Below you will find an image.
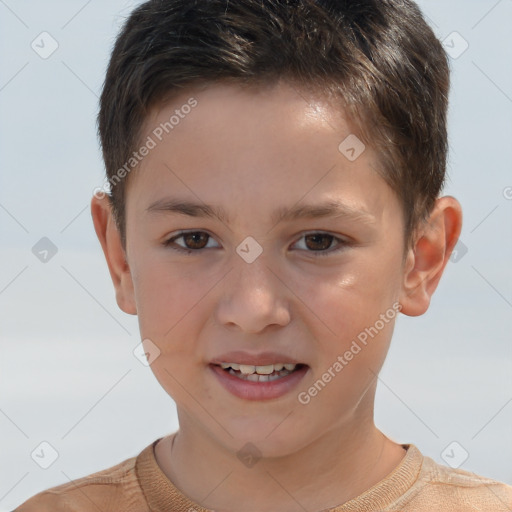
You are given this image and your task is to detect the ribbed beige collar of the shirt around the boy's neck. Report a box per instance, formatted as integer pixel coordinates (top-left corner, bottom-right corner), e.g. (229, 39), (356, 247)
(135, 433), (423, 512)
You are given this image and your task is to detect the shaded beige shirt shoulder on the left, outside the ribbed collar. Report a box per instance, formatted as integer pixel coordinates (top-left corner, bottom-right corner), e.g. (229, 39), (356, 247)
(14, 450), (146, 512)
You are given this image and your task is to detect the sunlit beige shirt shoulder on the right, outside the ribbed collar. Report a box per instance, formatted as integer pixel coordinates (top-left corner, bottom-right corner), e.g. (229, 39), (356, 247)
(404, 450), (512, 512)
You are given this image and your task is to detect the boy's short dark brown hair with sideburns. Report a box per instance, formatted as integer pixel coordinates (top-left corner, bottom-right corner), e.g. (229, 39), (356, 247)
(98, 0), (450, 252)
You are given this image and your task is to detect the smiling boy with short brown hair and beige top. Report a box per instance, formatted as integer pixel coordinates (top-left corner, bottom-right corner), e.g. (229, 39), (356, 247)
(17, 0), (512, 512)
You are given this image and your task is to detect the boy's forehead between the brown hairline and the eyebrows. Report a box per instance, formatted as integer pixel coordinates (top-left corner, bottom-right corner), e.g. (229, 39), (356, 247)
(127, 83), (396, 228)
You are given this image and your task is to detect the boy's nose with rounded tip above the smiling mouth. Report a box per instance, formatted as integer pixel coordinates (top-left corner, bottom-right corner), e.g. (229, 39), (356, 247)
(216, 256), (291, 334)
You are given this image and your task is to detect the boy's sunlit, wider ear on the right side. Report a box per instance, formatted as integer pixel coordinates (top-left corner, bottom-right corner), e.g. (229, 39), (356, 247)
(400, 196), (462, 316)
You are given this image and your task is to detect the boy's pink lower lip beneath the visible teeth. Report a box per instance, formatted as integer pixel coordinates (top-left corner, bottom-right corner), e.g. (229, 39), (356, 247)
(209, 364), (309, 400)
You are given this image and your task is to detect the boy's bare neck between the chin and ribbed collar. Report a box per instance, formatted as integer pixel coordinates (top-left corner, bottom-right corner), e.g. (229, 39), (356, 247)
(156, 418), (405, 512)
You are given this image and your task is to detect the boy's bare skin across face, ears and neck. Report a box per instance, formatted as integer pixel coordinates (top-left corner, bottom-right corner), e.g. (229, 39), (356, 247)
(91, 83), (462, 512)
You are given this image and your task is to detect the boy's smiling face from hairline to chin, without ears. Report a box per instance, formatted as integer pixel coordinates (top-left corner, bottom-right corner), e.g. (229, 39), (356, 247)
(123, 85), (404, 455)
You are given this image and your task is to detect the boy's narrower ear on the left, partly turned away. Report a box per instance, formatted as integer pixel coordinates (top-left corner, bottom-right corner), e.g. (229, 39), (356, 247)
(91, 194), (137, 315)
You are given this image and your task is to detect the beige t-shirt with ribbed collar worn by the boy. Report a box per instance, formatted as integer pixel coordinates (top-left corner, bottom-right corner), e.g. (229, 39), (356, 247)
(14, 432), (512, 512)
